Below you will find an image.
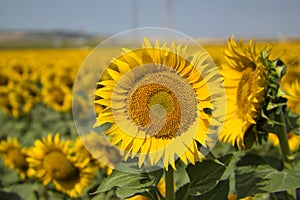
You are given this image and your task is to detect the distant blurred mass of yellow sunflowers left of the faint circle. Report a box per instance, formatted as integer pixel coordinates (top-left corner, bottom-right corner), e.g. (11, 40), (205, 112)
(0, 49), (89, 118)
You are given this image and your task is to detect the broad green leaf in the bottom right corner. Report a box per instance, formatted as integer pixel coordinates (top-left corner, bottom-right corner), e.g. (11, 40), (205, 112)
(235, 164), (300, 198)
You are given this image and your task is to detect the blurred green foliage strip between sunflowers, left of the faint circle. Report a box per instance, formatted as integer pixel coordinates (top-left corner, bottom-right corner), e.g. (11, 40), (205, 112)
(0, 104), (77, 145)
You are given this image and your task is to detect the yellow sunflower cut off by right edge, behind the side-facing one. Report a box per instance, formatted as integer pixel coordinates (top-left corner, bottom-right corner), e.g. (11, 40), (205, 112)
(282, 79), (300, 116)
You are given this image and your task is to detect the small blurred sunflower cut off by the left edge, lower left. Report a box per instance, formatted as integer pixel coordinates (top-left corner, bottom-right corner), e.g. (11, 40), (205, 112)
(0, 137), (28, 179)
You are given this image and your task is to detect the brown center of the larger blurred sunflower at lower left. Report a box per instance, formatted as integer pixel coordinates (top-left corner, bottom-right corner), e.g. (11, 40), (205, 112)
(43, 151), (79, 181)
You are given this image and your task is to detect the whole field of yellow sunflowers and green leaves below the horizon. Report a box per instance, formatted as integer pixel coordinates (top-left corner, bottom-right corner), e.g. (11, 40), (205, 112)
(0, 37), (300, 200)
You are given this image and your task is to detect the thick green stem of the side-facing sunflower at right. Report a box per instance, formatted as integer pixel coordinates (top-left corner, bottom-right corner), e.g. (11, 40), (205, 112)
(276, 112), (293, 168)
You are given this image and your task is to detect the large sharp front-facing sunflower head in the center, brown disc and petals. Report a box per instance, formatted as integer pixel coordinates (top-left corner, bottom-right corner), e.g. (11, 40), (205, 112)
(95, 38), (224, 169)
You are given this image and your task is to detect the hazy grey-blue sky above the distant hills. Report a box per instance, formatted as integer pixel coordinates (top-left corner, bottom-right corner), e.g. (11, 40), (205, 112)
(0, 0), (300, 37)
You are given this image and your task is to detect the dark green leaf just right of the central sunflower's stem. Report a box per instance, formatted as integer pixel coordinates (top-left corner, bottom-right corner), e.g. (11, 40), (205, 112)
(186, 155), (232, 196)
